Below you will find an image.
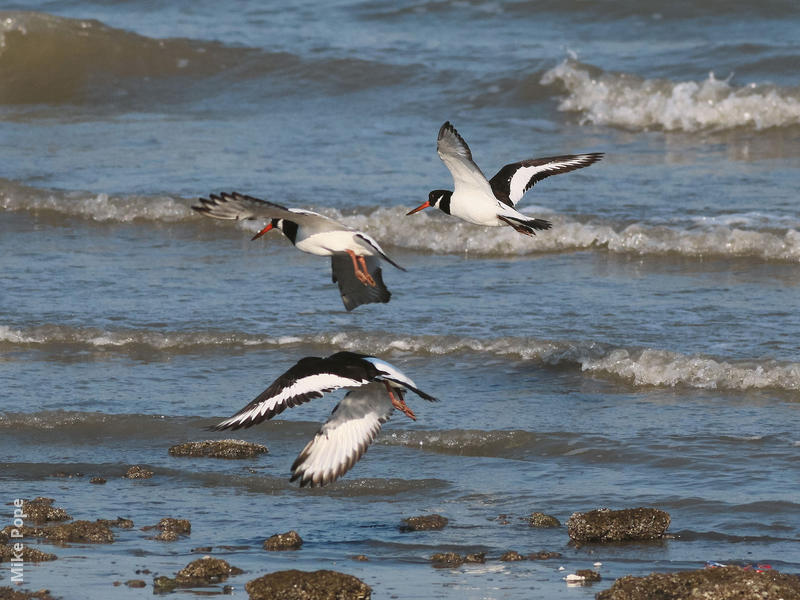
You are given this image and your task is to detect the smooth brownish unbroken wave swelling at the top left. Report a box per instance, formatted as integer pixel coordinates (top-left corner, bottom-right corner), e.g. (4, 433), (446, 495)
(0, 11), (418, 104)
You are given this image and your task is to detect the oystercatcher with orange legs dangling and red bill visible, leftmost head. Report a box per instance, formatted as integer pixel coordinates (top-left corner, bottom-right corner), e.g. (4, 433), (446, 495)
(192, 192), (405, 311)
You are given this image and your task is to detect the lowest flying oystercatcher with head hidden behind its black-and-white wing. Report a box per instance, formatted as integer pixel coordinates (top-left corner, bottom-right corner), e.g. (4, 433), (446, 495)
(211, 352), (436, 486)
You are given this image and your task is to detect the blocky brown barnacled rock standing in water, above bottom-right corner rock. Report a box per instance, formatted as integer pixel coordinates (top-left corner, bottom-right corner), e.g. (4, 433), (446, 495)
(567, 508), (670, 542)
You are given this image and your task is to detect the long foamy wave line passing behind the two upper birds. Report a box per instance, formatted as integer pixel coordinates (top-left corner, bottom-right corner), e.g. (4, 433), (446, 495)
(6, 180), (800, 262)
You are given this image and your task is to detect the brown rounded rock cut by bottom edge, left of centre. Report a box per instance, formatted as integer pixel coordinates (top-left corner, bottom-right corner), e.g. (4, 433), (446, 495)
(245, 569), (372, 600)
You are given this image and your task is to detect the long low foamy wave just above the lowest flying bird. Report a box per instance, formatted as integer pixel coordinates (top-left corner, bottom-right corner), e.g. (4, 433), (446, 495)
(0, 325), (800, 392)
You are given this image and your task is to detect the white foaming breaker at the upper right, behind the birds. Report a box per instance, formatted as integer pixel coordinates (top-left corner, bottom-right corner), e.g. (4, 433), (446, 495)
(541, 59), (800, 132)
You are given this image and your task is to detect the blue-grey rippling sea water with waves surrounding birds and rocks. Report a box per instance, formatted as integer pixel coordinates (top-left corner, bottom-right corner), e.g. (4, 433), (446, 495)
(0, 0), (800, 599)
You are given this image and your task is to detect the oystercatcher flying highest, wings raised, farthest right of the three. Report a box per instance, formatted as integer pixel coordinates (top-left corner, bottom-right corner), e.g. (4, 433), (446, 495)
(408, 121), (603, 235)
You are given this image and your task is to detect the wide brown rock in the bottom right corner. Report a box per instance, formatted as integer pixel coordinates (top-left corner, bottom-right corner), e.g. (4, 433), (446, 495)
(596, 566), (800, 600)
